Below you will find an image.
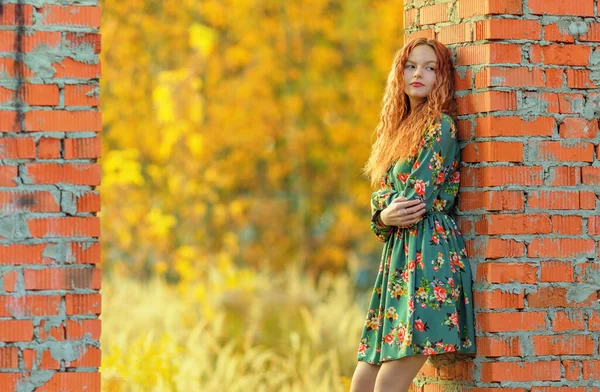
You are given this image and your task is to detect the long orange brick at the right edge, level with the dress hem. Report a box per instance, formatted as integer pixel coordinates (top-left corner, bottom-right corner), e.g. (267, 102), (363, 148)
(531, 334), (594, 355)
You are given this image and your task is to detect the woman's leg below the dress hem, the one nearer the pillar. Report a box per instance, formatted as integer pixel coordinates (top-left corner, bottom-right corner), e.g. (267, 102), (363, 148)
(375, 355), (428, 392)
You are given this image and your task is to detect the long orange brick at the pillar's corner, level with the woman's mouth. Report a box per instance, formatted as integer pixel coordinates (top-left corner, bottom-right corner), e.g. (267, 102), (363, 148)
(475, 67), (545, 88)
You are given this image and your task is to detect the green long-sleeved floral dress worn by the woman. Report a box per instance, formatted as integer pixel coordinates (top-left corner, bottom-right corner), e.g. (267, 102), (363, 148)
(358, 114), (475, 365)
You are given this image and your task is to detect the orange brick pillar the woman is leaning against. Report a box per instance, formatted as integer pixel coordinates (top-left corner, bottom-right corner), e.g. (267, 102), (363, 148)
(405, 0), (600, 392)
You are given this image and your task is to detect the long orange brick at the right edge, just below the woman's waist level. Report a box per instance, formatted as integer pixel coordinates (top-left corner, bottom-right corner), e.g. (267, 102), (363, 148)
(527, 238), (595, 257)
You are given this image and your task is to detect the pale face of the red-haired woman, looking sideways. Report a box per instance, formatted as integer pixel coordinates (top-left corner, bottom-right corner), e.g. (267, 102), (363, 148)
(404, 45), (437, 107)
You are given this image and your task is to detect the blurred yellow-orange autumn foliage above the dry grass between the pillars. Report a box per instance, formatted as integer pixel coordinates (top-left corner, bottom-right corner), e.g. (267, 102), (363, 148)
(100, 0), (403, 280)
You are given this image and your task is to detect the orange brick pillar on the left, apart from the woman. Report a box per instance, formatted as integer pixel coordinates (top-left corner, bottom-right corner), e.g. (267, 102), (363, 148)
(0, 0), (101, 392)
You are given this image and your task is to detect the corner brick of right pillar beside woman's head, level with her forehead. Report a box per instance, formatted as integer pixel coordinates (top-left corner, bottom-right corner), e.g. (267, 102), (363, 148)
(456, 43), (521, 65)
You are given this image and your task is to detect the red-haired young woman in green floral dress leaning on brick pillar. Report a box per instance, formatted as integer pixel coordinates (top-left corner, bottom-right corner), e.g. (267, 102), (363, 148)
(350, 38), (475, 392)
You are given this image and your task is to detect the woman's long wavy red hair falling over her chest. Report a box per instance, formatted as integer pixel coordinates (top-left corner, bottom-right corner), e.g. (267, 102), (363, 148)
(363, 38), (456, 188)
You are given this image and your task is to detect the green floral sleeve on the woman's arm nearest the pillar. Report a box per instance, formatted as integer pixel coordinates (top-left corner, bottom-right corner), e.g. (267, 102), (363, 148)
(400, 114), (459, 211)
